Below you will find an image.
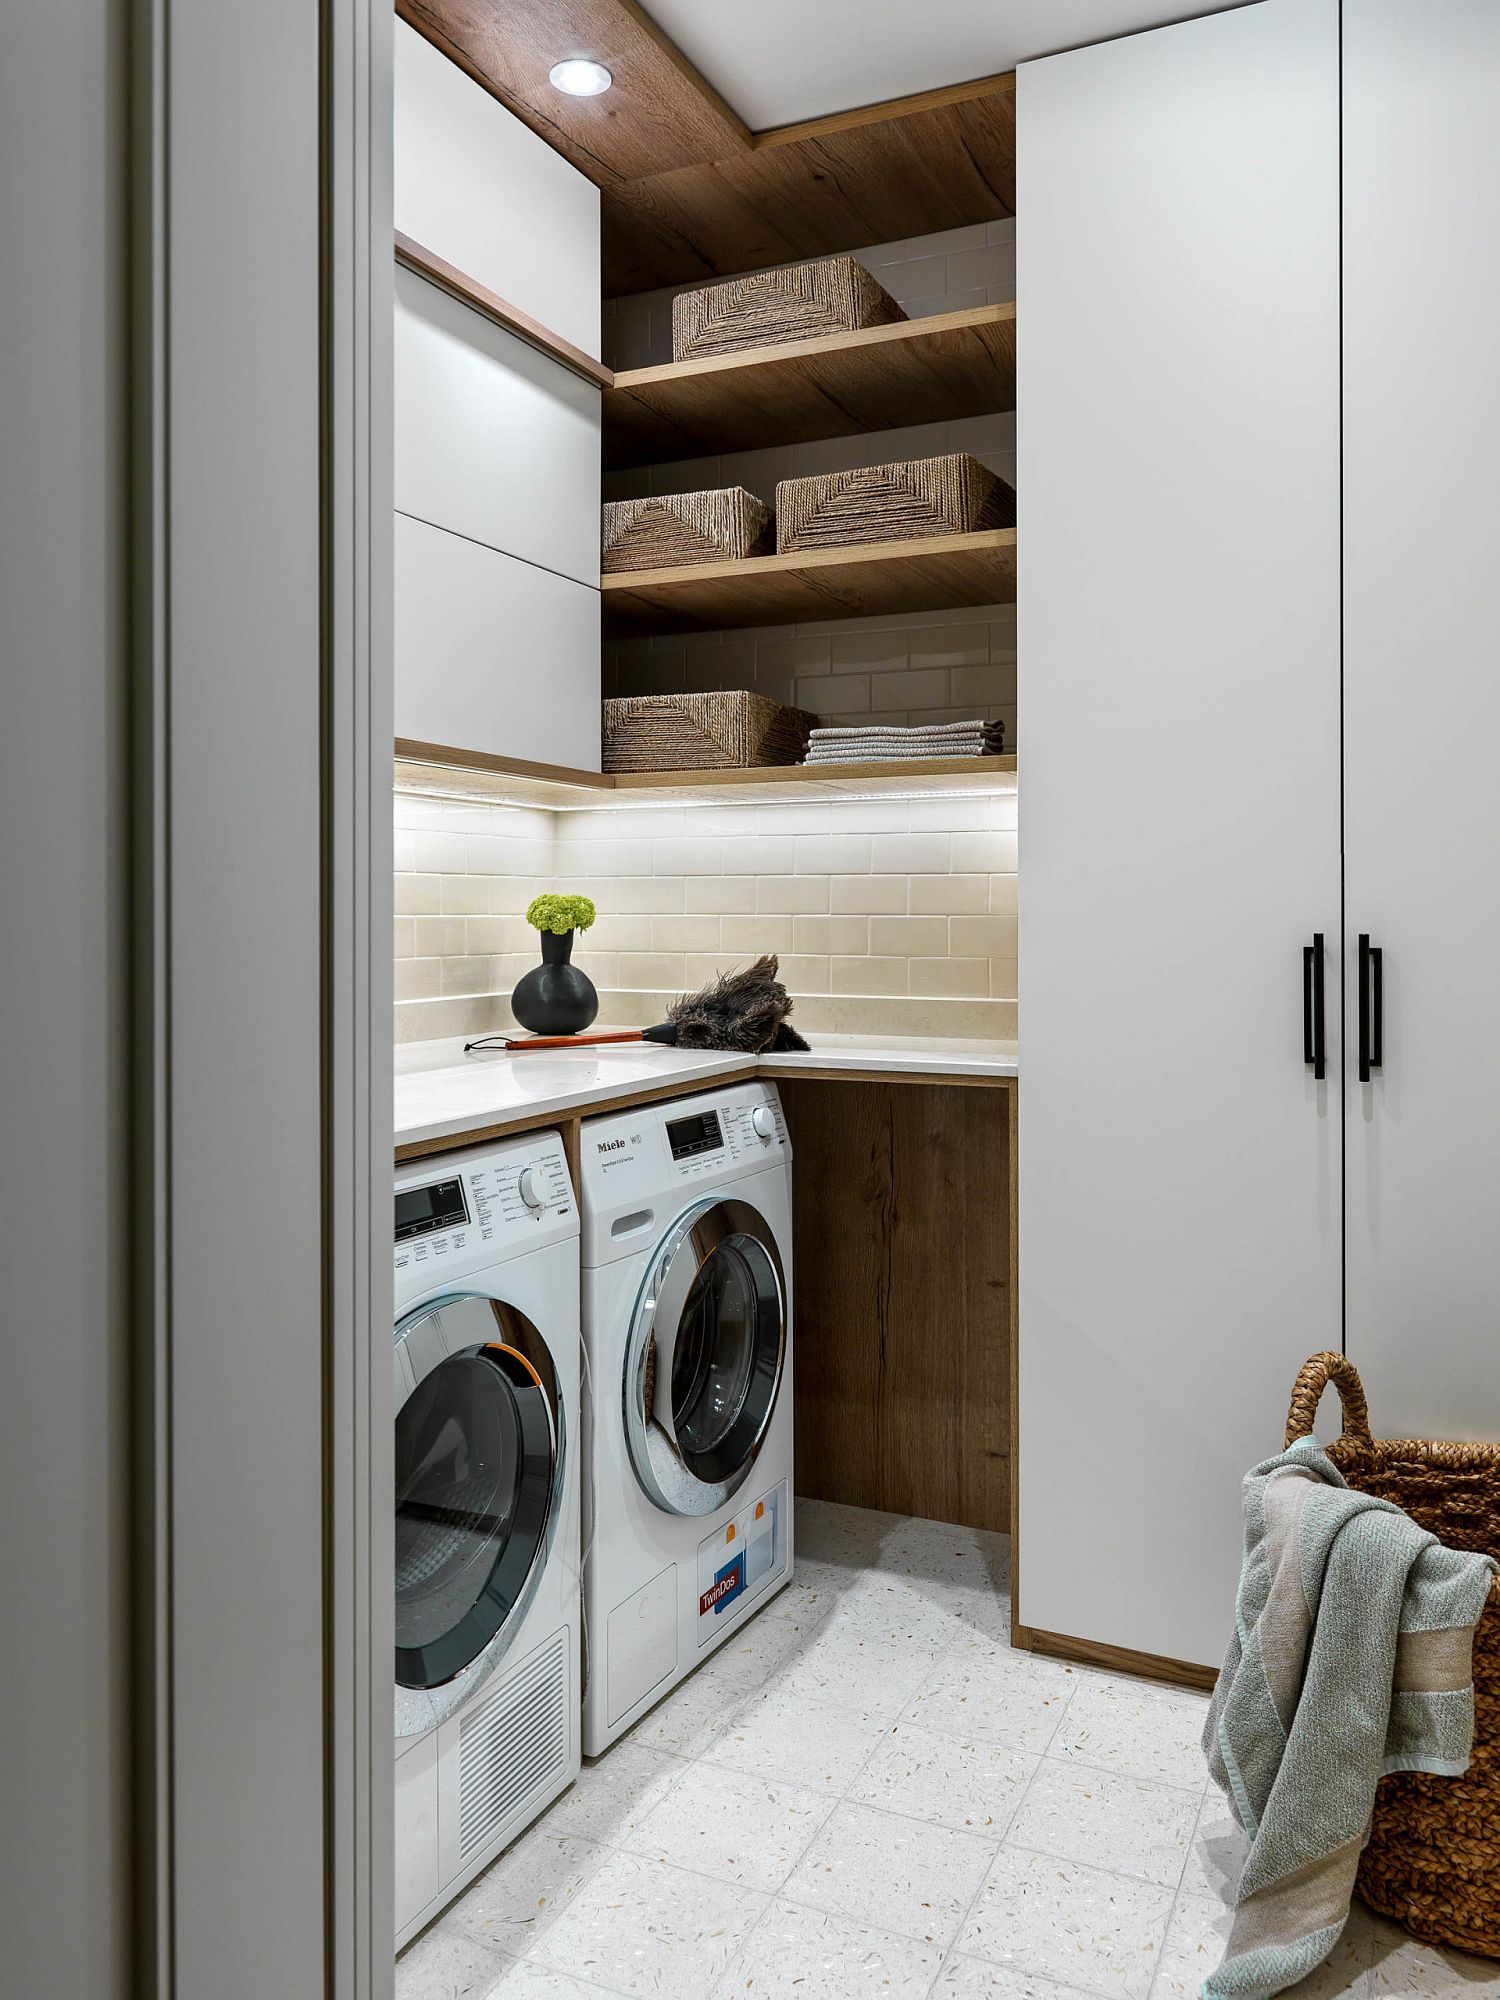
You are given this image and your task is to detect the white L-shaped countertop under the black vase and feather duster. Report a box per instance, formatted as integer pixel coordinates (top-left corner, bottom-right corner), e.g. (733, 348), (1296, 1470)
(396, 1034), (1016, 1146)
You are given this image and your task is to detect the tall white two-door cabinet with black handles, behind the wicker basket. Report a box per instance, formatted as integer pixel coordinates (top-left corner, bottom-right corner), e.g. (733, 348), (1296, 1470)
(1018, 0), (1500, 1664)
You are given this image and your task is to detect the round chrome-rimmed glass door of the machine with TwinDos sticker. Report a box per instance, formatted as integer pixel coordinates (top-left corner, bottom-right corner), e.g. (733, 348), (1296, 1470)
(624, 1198), (786, 1514)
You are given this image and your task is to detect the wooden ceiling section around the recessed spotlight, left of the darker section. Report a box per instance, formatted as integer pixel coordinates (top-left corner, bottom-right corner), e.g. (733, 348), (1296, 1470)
(396, 0), (750, 188)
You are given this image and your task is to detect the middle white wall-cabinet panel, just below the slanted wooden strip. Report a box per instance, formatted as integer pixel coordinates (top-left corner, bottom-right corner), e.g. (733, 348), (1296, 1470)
(396, 270), (600, 586)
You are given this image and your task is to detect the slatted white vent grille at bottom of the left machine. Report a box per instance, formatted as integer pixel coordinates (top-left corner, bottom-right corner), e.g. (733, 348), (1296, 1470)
(458, 1632), (568, 1858)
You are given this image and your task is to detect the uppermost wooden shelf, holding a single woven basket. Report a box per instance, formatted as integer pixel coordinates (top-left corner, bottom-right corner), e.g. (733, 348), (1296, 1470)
(604, 304), (1016, 466)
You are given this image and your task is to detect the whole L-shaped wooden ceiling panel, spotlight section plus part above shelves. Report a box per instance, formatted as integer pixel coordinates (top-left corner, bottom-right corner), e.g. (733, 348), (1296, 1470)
(396, 0), (1016, 296)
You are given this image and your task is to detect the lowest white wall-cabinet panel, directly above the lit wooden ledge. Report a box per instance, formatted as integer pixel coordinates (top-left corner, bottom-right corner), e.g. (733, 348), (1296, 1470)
(396, 514), (600, 770)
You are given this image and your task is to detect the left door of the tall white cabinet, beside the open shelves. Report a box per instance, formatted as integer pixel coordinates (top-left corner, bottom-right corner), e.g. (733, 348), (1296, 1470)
(1016, 0), (1342, 1666)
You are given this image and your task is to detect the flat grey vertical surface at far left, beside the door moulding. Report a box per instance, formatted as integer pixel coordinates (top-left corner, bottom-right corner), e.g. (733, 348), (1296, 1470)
(0, 0), (132, 2000)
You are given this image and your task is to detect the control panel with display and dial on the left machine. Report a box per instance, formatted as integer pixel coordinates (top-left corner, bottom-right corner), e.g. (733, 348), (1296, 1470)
(394, 1132), (578, 1308)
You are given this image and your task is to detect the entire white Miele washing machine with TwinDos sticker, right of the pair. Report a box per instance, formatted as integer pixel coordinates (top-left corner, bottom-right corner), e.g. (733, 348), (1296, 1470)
(582, 1082), (792, 1756)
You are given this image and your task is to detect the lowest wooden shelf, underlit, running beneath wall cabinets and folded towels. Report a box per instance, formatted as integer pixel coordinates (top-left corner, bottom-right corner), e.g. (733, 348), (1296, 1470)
(396, 738), (1016, 812)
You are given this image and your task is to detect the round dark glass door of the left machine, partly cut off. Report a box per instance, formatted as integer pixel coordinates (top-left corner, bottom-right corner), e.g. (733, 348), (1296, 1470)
(396, 1294), (562, 1706)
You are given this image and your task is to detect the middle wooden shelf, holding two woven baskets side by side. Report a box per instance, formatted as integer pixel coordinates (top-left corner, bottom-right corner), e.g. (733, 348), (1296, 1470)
(600, 528), (1016, 638)
